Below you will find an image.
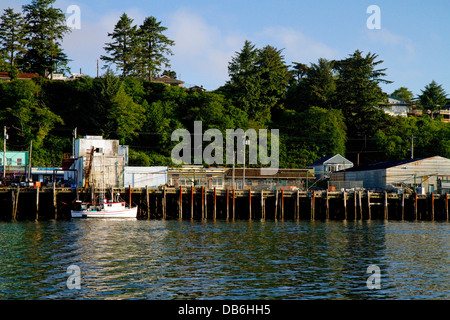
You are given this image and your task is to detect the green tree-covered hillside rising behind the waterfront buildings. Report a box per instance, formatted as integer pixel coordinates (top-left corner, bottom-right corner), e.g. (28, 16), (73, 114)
(0, 0), (450, 167)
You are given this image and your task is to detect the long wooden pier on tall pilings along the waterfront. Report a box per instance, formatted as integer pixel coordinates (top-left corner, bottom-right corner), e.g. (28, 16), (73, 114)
(0, 185), (449, 221)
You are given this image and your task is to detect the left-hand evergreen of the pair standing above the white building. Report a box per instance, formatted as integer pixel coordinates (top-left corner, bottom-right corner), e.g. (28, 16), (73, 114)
(100, 13), (137, 77)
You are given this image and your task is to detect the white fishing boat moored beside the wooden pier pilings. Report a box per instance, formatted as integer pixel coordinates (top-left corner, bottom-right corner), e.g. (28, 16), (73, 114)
(71, 199), (137, 218)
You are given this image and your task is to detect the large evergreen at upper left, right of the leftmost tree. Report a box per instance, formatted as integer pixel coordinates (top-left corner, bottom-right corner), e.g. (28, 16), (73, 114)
(21, 0), (70, 78)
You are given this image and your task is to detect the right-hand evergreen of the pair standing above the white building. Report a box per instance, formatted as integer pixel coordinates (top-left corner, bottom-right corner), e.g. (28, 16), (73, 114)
(137, 17), (175, 80)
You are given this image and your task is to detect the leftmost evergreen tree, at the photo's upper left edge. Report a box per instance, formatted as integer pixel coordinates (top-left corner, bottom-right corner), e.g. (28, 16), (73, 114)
(0, 8), (25, 79)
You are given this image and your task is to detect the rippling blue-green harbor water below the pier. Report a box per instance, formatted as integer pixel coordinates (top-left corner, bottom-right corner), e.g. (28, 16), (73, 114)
(0, 220), (450, 300)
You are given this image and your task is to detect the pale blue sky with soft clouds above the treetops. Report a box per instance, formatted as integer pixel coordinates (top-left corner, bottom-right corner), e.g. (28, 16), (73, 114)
(0, 0), (450, 96)
